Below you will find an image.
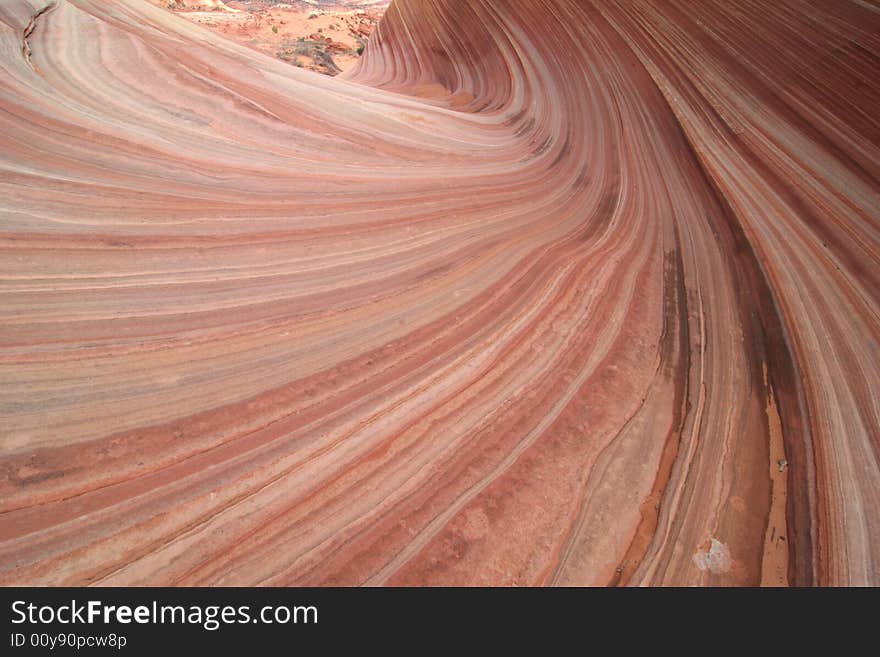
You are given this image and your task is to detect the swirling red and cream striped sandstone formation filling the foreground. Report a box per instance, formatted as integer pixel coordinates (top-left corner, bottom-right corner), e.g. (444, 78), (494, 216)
(0, 0), (880, 585)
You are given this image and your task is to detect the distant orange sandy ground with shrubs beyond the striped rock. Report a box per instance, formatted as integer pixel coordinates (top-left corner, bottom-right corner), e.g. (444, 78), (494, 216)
(151, 0), (388, 75)
